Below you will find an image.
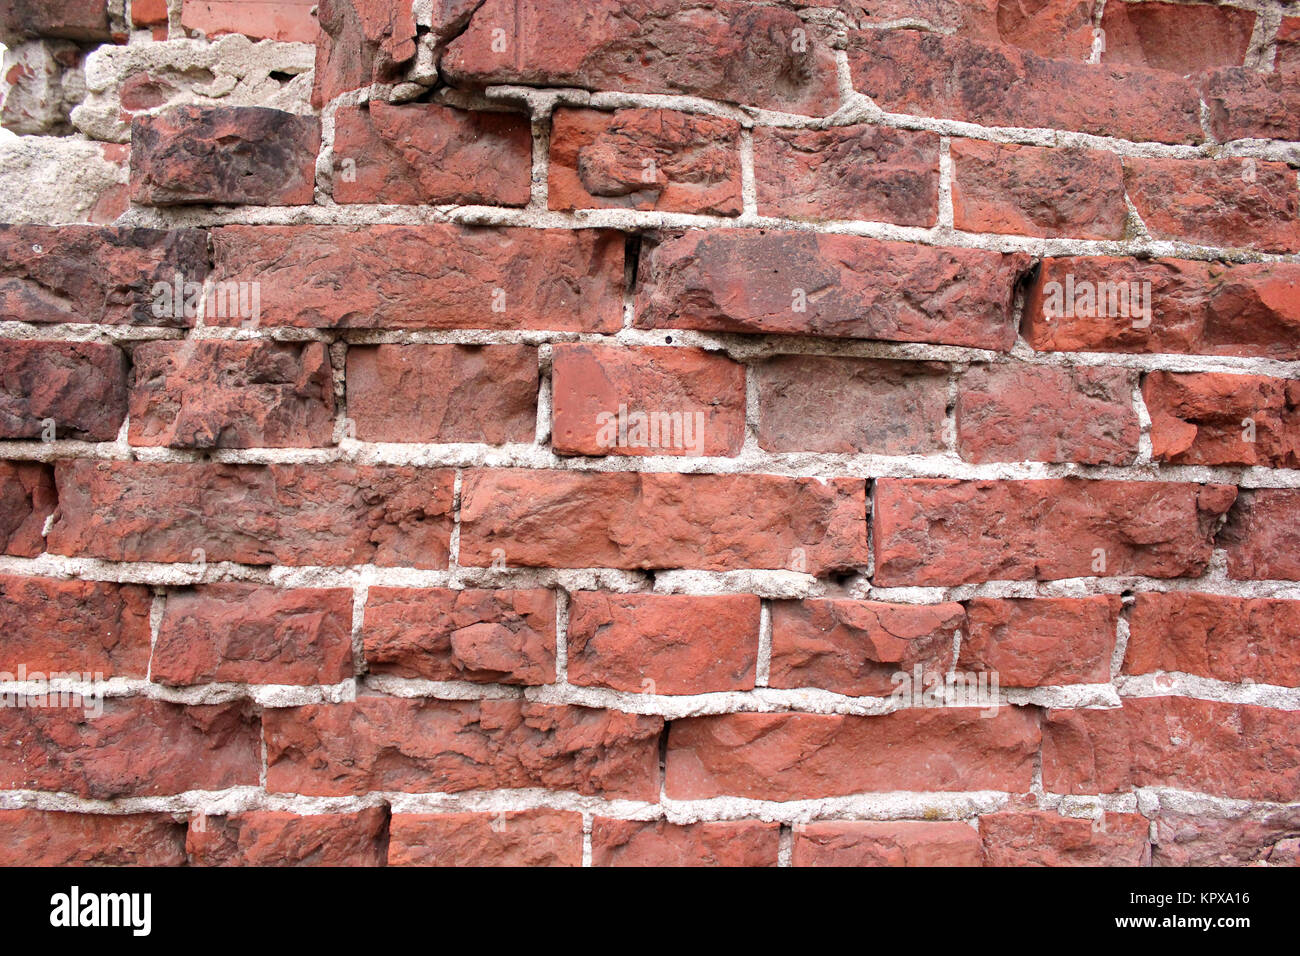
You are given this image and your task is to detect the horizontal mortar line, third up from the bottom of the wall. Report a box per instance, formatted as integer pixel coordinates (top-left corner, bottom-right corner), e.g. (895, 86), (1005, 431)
(0, 551), (1300, 605)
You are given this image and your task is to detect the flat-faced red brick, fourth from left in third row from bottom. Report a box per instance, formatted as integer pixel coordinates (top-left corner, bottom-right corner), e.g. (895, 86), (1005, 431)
(568, 591), (761, 695)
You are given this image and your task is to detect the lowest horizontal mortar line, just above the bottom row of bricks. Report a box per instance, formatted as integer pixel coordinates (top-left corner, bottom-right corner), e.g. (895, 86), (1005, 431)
(0, 786), (1300, 823)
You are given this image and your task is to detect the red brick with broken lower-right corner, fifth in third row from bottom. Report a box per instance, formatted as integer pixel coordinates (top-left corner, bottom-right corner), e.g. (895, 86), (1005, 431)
(768, 600), (966, 697)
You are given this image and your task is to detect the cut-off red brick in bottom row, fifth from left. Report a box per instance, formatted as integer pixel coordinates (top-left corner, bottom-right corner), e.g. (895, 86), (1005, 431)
(790, 821), (983, 866)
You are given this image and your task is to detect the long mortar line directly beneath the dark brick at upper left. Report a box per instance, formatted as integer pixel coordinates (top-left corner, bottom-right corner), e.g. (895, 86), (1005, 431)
(117, 203), (1300, 263)
